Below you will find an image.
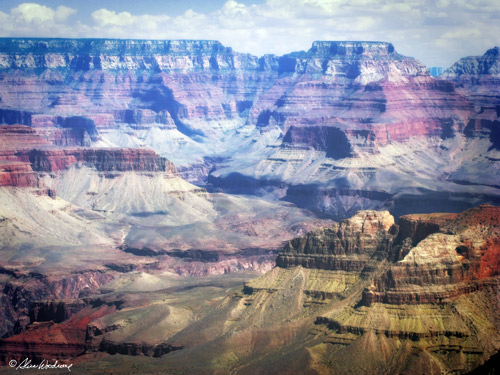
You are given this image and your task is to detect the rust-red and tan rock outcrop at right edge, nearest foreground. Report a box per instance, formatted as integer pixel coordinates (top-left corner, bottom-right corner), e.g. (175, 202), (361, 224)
(363, 206), (500, 305)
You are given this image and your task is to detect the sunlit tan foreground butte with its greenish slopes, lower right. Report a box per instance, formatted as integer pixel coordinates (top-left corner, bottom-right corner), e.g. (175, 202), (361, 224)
(239, 205), (500, 374)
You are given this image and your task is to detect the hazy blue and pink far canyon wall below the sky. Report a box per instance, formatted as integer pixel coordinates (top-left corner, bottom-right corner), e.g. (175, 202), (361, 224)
(0, 38), (500, 219)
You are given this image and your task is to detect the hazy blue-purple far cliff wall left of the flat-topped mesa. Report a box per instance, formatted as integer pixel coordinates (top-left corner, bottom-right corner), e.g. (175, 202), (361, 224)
(0, 39), (270, 137)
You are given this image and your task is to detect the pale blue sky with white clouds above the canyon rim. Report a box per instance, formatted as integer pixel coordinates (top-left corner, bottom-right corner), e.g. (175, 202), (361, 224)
(0, 0), (500, 67)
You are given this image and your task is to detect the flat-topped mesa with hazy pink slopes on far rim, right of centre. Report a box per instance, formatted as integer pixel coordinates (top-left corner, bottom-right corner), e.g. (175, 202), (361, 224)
(250, 42), (470, 146)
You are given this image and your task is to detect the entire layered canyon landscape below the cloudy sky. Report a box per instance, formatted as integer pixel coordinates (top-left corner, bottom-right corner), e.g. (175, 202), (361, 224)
(0, 38), (500, 375)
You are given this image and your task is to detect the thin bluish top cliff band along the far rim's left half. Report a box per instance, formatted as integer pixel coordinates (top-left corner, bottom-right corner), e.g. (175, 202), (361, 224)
(0, 38), (259, 71)
